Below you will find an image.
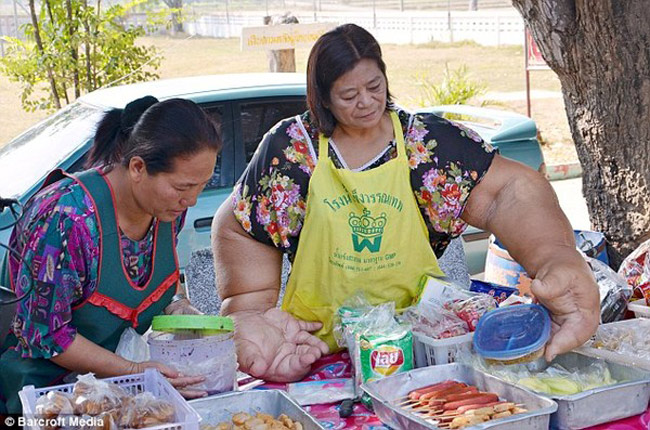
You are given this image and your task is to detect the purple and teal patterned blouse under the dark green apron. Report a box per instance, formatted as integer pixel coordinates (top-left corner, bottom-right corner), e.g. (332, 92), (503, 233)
(9, 179), (185, 358)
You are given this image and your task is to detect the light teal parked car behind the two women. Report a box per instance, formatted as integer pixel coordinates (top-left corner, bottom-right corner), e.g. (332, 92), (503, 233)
(0, 73), (543, 273)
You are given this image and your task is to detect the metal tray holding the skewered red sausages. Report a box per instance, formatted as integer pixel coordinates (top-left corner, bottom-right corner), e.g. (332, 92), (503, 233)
(362, 363), (557, 430)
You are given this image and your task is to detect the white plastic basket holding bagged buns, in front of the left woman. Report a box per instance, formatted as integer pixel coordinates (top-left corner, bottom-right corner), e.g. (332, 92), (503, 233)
(18, 369), (200, 430)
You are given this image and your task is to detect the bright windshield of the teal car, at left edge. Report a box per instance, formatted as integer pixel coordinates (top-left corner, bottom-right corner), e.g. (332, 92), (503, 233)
(0, 102), (103, 198)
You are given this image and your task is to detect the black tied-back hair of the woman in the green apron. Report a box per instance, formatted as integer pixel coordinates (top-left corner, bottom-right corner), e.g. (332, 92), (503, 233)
(86, 96), (222, 175)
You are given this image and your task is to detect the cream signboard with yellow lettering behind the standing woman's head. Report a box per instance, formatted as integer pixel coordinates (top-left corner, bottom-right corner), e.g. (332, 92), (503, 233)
(241, 23), (337, 51)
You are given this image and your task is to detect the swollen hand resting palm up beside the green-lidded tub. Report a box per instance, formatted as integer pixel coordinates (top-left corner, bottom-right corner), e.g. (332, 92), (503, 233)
(230, 308), (328, 382)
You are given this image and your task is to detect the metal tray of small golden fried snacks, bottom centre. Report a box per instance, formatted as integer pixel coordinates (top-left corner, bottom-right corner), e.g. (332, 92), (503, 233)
(189, 390), (324, 430)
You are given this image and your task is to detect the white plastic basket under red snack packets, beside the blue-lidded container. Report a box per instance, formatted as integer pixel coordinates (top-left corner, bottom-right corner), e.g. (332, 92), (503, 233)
(413, 332), (474, 367)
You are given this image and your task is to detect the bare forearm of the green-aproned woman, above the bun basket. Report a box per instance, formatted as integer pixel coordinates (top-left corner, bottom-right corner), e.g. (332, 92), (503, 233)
(50, 334), (137, 377)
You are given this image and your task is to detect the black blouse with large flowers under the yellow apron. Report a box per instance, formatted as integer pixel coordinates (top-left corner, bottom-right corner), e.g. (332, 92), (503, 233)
(232, 109), (495, 259)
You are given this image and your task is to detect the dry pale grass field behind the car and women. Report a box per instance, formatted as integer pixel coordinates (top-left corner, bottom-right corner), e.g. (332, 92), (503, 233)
(0, 37), (575, 163)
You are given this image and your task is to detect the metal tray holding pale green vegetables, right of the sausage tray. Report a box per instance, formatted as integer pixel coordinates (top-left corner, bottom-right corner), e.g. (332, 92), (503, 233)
(549, 352), (650, 430)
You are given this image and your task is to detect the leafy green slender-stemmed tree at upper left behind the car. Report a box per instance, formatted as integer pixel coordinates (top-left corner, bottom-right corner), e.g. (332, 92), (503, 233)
(0, 0), (161, 110)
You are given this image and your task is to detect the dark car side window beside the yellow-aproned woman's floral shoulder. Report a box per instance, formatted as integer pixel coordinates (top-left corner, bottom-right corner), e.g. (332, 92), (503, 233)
(240, 98), (307, 163)
